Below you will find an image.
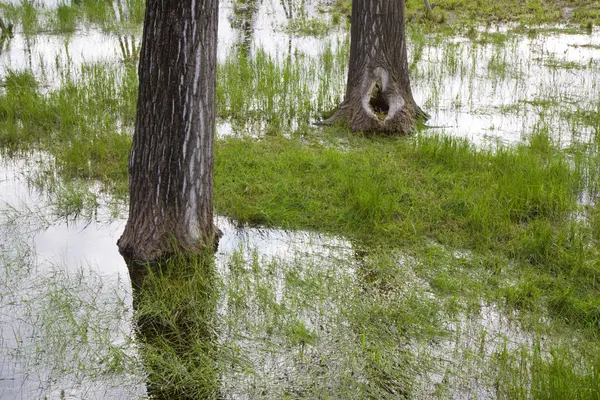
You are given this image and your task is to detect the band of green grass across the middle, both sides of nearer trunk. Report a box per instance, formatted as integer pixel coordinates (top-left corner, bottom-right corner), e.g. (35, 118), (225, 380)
(0, 56), (598, 334)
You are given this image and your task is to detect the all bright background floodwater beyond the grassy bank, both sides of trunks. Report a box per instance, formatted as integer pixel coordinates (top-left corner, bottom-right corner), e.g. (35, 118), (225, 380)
(0, 0), (600, 147)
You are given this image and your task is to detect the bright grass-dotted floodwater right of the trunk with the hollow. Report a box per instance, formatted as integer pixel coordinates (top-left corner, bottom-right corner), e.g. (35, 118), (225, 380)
(412, 27), (600, 147)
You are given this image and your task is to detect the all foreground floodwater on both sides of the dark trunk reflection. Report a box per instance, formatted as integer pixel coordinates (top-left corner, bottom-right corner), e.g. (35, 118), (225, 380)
(0, 155), (544, 399)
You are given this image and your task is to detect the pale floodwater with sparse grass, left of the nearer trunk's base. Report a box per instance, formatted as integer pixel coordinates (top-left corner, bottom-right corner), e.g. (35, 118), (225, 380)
(0, 156), (144, 399)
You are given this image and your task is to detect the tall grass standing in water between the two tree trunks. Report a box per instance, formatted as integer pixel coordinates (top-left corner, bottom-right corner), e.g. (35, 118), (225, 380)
(217, 43), (347, 135)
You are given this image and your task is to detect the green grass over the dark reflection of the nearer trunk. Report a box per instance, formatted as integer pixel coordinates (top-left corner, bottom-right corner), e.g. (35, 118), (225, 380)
(133, 255), (219, 399)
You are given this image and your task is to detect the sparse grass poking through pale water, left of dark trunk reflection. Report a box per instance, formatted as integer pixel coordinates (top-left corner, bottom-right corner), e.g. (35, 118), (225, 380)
(0, 206), (143, 399)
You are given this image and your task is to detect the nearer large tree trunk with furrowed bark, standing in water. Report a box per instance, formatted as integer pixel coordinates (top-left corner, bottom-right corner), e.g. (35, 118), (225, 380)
(117, 0), (218, 261)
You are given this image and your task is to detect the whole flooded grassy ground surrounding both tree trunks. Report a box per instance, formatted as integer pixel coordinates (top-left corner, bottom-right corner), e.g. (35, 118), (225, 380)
(0, 0), (600, 399)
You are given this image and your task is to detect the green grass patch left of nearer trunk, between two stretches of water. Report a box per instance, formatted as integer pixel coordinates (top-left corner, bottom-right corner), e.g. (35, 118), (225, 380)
(0, 64), (137, 196)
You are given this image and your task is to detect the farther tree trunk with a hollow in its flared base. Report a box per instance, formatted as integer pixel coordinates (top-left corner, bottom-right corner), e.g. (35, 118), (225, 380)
(325, 0), (426, 133)
